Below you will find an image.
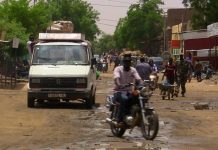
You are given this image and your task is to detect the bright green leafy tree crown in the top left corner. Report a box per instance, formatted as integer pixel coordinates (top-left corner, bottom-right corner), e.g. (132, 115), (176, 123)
(0, 0), (50, 35)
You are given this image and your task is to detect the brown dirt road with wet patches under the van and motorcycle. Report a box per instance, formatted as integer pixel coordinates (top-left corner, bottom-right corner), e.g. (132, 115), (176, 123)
(0, 69), (218, 150)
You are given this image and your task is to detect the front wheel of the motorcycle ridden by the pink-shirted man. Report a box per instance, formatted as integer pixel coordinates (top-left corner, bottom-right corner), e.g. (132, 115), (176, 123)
(141, 111), (159, 140)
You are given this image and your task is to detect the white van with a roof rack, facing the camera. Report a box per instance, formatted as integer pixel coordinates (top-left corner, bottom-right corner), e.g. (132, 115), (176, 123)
(27, 33), (96, 108)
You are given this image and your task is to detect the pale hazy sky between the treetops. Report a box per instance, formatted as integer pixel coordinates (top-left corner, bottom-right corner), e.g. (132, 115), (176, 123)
(86, 0), (186, 34)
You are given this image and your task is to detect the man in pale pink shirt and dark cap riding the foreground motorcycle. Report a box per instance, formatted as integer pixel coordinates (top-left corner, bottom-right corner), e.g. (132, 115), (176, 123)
(114, 54), (141, 125)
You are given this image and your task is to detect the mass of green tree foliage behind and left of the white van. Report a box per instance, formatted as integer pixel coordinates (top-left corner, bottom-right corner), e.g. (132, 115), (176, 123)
(0, 0), (100, 56)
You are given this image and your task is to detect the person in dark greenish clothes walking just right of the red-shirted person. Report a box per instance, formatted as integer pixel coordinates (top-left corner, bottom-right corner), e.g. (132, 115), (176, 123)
(176, 55), (189, 97)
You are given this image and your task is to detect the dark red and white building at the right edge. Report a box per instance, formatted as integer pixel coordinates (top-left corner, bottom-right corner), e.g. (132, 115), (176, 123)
(183, 30), (218, 70)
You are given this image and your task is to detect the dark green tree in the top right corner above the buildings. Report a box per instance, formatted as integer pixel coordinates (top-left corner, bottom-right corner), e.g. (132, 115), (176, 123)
(184, 0), (218, 29)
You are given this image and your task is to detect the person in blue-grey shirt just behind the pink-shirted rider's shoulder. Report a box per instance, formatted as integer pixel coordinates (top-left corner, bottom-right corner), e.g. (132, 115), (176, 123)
(135, 57), (152, 80)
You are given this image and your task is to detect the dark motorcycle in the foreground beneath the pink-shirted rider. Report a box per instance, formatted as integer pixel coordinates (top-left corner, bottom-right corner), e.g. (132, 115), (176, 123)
(106, 81), (159, 140)
